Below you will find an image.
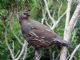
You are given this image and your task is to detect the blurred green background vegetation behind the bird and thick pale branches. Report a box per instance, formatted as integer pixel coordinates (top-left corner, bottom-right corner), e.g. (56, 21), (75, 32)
(0, 0), (80, 60)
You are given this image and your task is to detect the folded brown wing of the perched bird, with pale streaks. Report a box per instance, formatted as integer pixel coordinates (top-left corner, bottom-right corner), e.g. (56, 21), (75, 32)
(30, 26), (57, 44)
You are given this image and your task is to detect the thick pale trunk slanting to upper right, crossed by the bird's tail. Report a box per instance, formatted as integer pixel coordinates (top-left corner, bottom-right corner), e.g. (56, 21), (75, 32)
(60, 3), (80, 60)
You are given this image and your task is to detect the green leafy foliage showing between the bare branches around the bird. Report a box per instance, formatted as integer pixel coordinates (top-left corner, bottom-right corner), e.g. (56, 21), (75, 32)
(0, 0), (80, 60)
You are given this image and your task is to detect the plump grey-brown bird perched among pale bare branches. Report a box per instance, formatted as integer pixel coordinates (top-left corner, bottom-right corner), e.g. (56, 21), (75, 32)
(19, 11), (69, 60)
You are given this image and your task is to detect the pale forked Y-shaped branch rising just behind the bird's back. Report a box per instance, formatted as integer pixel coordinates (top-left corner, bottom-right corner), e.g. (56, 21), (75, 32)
(44, 0), (65, 30)
